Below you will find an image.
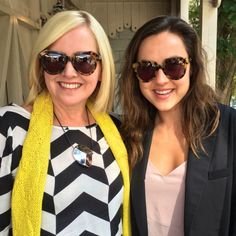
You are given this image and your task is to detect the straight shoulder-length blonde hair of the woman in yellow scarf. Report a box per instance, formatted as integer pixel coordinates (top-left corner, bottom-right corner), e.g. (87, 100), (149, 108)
(25, 11), (115, 112)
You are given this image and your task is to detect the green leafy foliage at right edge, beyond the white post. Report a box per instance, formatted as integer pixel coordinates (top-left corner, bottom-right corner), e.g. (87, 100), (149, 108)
(217, 0), (236, 103)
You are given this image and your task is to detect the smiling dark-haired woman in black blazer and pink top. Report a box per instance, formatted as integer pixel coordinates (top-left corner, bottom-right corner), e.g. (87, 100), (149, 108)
(120, 16), (236, 236)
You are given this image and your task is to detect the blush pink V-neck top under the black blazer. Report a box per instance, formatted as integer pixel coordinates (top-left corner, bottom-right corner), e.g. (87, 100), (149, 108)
(145, 161), (186, 236)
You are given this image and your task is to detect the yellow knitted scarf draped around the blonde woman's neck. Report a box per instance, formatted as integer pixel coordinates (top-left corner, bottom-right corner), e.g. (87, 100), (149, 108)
(12, 93), (130, 236)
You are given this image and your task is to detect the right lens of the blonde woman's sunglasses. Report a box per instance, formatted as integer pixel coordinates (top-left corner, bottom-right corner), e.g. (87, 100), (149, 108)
(73, 54), (97, 75)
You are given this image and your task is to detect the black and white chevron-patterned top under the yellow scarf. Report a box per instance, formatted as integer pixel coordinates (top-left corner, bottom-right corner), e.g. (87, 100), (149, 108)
(0, 105), (123, 236)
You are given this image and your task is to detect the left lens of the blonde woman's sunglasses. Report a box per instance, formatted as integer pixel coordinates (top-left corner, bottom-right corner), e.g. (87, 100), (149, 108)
(40, 51), (67, 75)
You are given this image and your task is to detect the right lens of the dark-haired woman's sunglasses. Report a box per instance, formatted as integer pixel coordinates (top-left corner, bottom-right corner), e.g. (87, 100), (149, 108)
(163, 58), (186, 80)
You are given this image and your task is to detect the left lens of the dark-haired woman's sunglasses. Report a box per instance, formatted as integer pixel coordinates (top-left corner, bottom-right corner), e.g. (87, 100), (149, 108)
(136, 61), (155, 82)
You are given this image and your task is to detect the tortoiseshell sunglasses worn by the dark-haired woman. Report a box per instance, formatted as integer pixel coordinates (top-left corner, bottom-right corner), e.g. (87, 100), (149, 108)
(132, 57), (190, 83)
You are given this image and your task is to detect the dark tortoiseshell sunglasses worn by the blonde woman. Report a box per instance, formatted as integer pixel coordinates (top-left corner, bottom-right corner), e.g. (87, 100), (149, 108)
(39, 50), (101, 75)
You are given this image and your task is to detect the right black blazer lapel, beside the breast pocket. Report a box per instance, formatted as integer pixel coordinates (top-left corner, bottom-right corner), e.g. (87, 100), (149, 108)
(184, 135), (216, 236)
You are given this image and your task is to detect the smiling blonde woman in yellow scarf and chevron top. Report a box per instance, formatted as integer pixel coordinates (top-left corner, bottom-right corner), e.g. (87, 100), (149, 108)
(0, 11), (129, 236)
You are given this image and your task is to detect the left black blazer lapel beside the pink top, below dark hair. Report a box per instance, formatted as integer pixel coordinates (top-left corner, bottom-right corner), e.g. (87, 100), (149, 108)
(131, 130), (153, 236)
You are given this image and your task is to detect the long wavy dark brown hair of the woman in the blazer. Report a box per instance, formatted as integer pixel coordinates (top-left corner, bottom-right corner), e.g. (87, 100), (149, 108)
(119, 16), (219, 168)
